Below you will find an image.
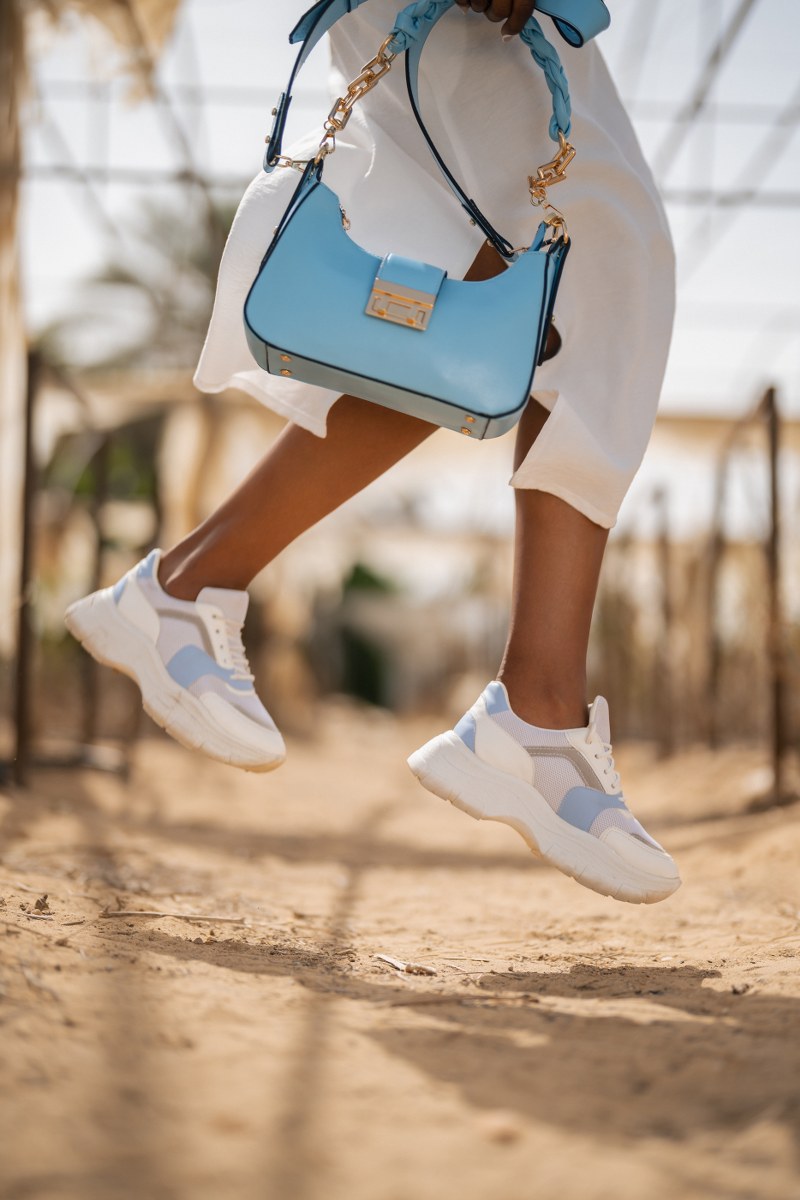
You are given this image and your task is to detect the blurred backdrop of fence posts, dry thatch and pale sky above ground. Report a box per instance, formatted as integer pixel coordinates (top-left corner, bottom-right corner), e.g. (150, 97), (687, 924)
(0, 0), (800, 804)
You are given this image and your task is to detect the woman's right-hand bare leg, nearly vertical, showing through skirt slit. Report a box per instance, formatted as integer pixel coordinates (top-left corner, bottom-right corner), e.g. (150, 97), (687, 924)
(498, 402), (608, 728)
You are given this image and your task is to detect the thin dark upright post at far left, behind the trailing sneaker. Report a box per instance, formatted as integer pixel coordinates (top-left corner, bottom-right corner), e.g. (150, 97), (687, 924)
(13, 350), (41, 787)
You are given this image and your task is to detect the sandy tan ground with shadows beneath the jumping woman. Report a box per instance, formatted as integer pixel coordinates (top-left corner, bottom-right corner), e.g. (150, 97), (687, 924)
(0, 708), (800, 1200)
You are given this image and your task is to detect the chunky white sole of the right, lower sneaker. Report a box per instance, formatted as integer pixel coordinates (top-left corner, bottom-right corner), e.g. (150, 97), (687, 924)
(408, 731), (680, 904)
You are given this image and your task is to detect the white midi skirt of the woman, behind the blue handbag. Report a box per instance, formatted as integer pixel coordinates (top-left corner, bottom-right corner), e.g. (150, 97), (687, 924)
(194, 0), (674, 527)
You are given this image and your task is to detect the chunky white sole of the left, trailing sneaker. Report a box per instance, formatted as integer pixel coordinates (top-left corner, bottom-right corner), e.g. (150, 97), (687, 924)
(64, 588), (285, 772)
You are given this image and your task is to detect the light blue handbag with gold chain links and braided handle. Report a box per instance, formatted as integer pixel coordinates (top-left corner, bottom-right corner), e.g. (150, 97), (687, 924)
(245, 0), (607, 438)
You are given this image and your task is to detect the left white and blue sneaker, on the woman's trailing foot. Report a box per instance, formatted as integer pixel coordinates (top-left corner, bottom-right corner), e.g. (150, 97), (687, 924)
(65, 550), (285, 770)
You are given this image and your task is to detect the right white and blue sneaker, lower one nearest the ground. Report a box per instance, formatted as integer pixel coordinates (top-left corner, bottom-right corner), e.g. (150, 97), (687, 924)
(408, 679), (680, 904)
